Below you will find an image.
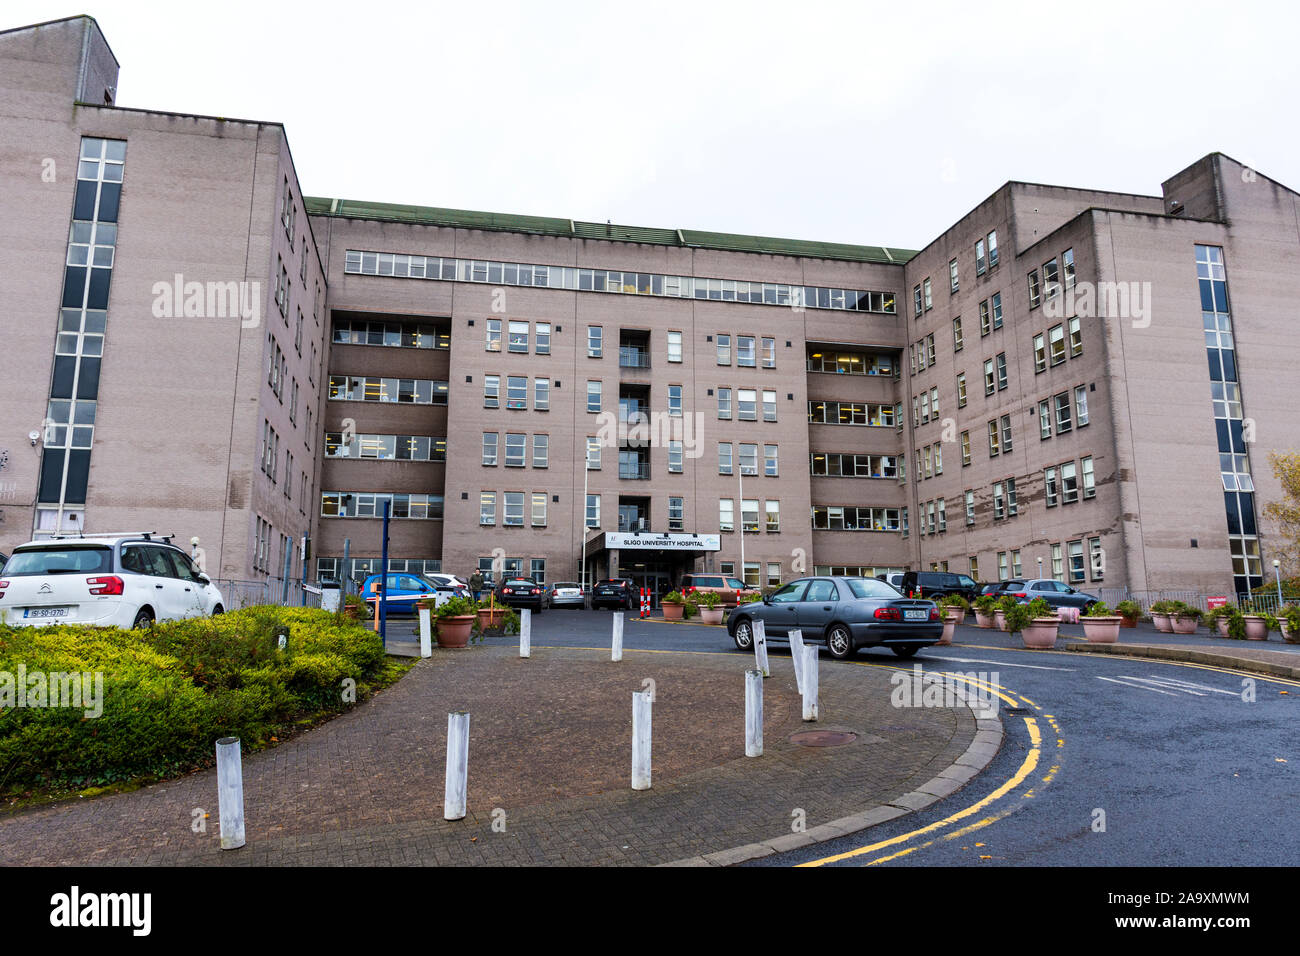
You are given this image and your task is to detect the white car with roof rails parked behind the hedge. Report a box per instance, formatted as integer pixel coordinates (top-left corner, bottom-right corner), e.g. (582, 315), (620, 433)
(0, 533), (225, 627)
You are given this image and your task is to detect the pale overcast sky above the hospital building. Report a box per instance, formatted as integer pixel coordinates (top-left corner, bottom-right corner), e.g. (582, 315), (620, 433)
(10, 0), (1300, 248)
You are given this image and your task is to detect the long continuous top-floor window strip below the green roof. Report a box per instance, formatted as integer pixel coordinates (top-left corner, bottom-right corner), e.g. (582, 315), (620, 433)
(343, 250), (896, 315)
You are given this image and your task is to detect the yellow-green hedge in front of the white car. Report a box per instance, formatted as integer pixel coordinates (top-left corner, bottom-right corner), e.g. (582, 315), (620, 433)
(0, 607), (397, 792)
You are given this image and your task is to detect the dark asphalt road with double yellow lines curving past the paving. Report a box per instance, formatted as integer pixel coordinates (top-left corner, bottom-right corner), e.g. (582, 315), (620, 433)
(403, 610), (1300, 866)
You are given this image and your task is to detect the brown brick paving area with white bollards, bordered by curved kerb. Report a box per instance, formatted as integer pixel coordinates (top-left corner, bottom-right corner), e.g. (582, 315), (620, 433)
(0, 646), (989, 866)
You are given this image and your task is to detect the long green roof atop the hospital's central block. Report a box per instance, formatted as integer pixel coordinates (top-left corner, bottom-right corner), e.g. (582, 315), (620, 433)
(303, 196), (917, 265)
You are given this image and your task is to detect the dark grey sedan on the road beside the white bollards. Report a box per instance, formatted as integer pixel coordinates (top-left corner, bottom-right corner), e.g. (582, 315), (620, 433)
(727, 578), (944, 659)
